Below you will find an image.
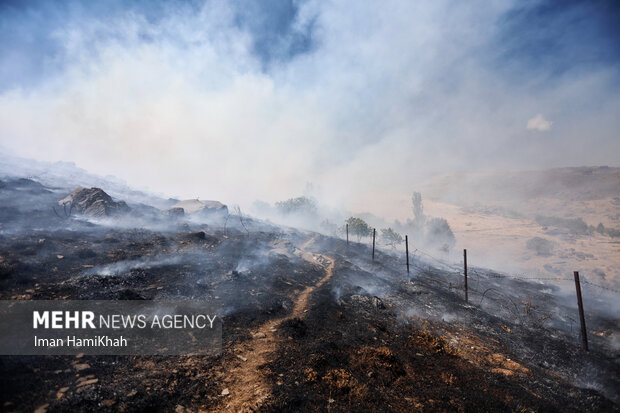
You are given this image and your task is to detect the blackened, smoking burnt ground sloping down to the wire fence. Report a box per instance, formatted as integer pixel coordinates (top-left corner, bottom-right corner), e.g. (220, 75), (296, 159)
(0, 182), (619, 412)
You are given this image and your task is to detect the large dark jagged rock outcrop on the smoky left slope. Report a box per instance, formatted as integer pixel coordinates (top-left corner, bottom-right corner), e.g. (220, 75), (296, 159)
(58, 187), (131, 217)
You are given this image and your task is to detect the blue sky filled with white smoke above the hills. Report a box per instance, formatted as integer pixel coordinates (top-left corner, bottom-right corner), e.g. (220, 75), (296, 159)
(0, 0), (620, 211)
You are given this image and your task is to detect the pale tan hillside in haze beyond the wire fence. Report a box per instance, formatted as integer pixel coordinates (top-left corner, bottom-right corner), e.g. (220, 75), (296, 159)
(382, 167), (620, 298)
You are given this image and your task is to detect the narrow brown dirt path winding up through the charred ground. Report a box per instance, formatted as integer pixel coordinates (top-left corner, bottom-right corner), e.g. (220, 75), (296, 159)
(215, 253), (334, 412)
